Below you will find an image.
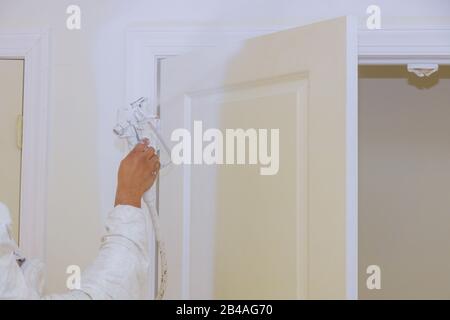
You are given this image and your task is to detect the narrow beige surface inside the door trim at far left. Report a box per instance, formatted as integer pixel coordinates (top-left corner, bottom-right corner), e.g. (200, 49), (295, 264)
(0, 59), (23, 241)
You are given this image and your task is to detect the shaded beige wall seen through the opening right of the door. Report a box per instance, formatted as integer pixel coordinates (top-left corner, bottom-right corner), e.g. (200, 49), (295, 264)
(359, 66), (450, 299)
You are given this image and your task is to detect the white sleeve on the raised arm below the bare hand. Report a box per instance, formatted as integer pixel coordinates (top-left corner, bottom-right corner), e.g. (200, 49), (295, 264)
(46, 206), (150, 299)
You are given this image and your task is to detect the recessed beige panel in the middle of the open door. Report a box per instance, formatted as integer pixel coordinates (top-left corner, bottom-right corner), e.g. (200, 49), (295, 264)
(187, 75), (307, 299)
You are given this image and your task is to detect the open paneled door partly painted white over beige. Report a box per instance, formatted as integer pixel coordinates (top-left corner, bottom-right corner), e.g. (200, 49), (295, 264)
(159, 18), (357, 299)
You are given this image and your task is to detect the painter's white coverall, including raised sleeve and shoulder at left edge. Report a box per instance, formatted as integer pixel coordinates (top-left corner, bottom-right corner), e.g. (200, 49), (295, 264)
(0, 203), (150, 299)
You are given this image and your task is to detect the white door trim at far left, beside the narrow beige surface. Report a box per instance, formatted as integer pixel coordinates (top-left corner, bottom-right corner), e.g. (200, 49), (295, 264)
(0, 30), (49, 260)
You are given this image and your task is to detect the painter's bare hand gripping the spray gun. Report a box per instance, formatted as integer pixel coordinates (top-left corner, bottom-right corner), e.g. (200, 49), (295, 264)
(115, 140), (161, 208)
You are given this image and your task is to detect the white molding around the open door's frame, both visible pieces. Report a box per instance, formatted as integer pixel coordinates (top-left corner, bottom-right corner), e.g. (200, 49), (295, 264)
(124, 26), (450, 103)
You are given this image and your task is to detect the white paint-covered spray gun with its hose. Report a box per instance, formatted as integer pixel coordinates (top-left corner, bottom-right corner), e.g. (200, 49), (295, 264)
(113, 98), (171, 299)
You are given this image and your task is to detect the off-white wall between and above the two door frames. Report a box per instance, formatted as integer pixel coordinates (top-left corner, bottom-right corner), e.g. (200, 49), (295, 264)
(0, 0), (450, 291)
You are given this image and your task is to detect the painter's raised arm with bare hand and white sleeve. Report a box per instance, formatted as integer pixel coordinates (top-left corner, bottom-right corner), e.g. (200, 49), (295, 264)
(47, 141), (160, 299)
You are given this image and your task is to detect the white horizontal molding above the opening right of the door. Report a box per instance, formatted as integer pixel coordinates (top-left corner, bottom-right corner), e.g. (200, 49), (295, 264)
(358, 27), (450, 65)
